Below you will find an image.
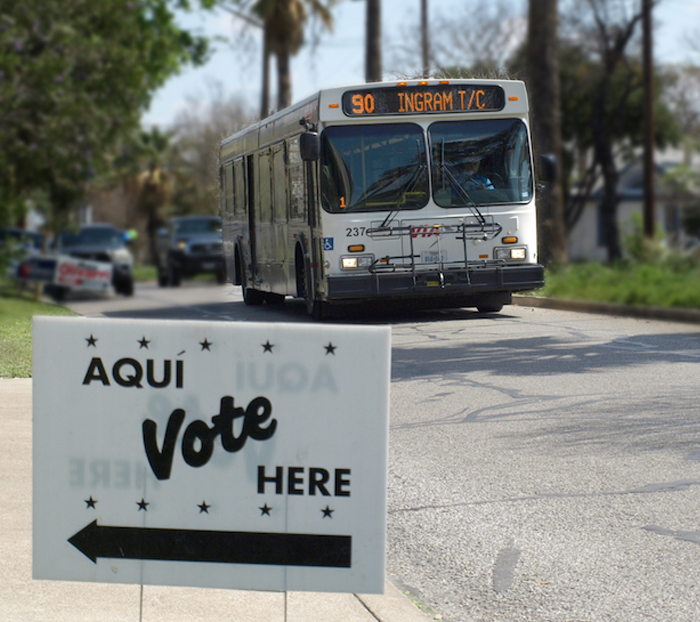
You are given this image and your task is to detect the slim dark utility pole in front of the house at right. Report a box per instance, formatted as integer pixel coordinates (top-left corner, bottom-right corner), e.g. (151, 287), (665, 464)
(642, 0), (656, 239)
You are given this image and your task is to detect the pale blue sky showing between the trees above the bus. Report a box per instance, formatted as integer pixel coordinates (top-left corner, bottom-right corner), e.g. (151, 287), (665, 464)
(143, 0), (700, 128)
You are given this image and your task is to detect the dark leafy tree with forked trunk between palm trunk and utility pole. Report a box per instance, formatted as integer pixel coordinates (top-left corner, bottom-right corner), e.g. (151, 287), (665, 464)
(561, 0), (675, 261)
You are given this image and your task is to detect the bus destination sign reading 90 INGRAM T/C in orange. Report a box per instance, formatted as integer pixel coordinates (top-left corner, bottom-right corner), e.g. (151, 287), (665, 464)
(343, 84), (505, 117)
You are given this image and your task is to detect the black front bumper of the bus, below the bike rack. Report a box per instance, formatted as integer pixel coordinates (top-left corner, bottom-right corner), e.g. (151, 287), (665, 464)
(326, 264), (544, 302)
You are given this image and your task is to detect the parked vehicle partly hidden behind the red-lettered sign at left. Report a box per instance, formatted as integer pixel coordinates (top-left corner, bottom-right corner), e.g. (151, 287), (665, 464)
(51, 224), (134, 296)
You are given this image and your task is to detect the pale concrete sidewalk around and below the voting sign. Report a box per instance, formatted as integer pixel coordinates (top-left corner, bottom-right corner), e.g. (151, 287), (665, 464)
(0, 379), (429, 622)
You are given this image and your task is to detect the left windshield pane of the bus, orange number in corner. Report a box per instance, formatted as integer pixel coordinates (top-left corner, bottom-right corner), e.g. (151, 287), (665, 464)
(321, 123), (429, 213)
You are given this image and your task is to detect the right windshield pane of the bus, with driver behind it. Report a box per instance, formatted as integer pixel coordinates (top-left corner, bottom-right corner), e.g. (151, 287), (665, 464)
(428, 119), (533, 207)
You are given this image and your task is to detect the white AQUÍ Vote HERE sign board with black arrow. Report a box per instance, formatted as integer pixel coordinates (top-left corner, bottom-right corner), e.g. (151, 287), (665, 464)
(33, 317), (391, 593)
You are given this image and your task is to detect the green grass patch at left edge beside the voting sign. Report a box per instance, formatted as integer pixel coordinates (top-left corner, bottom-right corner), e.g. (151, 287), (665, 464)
(0, 280), (75, 378)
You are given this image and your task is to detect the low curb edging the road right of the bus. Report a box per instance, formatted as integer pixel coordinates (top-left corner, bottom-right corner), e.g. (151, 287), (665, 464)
(513, 294), (700, 324)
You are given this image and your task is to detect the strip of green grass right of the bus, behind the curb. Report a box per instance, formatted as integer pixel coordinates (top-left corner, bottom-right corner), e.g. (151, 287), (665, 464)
(535, 259), (700, 309)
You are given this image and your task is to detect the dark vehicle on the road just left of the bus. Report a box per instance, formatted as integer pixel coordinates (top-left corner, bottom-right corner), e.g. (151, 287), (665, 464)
(157, 216), (226, 287)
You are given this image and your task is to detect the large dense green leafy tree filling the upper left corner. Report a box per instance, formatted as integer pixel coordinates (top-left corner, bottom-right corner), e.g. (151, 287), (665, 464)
(0, 0), (211, 229)
